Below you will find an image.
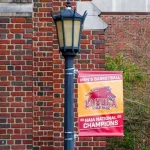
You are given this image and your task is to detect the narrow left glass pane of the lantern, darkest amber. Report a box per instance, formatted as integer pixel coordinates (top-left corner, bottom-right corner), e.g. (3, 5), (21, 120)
(56, 21), (64, 47)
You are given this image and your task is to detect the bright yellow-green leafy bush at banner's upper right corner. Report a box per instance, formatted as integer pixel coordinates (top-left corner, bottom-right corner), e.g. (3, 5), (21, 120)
(106, 53), (146, 89)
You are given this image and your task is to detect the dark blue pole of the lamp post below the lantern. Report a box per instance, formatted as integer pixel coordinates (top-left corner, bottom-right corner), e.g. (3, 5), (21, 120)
(64, 55), (75, 150)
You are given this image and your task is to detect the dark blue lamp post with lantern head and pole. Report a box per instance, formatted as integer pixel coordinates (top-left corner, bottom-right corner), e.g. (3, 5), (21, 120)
(52, 0), (87, 150)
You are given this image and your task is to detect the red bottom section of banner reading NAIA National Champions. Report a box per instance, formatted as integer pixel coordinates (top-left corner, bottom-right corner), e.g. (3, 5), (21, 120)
(78, 114), (123, 136)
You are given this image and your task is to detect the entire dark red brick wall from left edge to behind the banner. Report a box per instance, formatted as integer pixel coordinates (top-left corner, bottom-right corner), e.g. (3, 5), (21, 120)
(0, 0), (106, 150)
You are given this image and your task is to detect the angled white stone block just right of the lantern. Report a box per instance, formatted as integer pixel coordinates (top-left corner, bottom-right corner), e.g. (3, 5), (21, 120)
(77, 2), (108, 30)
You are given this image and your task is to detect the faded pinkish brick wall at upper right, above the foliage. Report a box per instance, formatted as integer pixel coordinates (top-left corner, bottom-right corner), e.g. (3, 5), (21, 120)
(102, 13), (150, 56)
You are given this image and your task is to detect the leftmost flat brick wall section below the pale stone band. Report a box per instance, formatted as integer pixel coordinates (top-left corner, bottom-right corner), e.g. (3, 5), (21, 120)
(0, 17), (33, 150)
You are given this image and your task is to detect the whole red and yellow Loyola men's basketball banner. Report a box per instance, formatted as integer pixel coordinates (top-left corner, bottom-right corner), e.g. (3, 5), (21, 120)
(78, 71), (124, 137)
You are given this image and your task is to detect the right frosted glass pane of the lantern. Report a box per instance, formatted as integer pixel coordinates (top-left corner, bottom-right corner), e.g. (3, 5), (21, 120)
(74, 21), (81, 47)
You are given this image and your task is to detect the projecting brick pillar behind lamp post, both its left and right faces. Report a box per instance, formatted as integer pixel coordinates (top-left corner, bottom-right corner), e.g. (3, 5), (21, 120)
(33, 0), (106, 150)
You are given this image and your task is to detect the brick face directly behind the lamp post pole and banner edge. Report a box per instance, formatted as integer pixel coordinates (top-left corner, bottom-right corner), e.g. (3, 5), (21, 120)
(53, 0), (106, 150)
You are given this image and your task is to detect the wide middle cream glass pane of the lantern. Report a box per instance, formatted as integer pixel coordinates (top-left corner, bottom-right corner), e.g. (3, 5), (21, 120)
(64, 20), (72, 46)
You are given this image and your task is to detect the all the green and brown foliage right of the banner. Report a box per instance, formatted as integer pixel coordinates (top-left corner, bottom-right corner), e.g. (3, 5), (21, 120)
(106, 53), (150, 150)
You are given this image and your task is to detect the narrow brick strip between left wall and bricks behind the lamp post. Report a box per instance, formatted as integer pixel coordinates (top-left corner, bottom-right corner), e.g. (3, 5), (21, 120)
(33, 0), (53, 150)
